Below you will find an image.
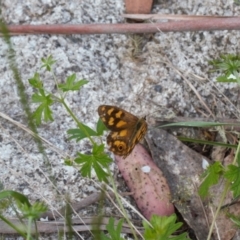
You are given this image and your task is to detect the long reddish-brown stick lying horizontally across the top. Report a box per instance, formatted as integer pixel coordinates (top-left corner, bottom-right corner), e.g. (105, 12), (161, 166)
(0, 17), (240, 34)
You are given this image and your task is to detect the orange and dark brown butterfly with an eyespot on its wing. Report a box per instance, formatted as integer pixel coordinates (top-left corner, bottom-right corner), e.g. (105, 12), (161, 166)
(98, 105), (147, 158)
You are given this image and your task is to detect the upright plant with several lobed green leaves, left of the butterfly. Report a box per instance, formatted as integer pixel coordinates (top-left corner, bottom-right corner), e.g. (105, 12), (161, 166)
(29, 56), (112, 182)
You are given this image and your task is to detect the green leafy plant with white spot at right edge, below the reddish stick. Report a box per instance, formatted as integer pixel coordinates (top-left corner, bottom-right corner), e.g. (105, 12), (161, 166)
(209, 54), (240, 84)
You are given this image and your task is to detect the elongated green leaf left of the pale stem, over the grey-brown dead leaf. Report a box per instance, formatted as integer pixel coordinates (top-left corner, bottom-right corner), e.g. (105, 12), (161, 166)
(198, 162), (223, 198)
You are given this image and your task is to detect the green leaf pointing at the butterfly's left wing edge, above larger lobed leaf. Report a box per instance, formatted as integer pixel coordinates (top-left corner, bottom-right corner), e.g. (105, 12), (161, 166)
(67, 123), (98, 142)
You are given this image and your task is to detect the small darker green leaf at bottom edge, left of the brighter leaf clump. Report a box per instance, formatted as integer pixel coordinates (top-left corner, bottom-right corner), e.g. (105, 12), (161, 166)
(100, 217), (124, 240)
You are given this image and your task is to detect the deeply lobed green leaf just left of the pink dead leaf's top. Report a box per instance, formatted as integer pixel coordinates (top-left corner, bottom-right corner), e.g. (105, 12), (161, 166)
(74, 144), (112, 182)
